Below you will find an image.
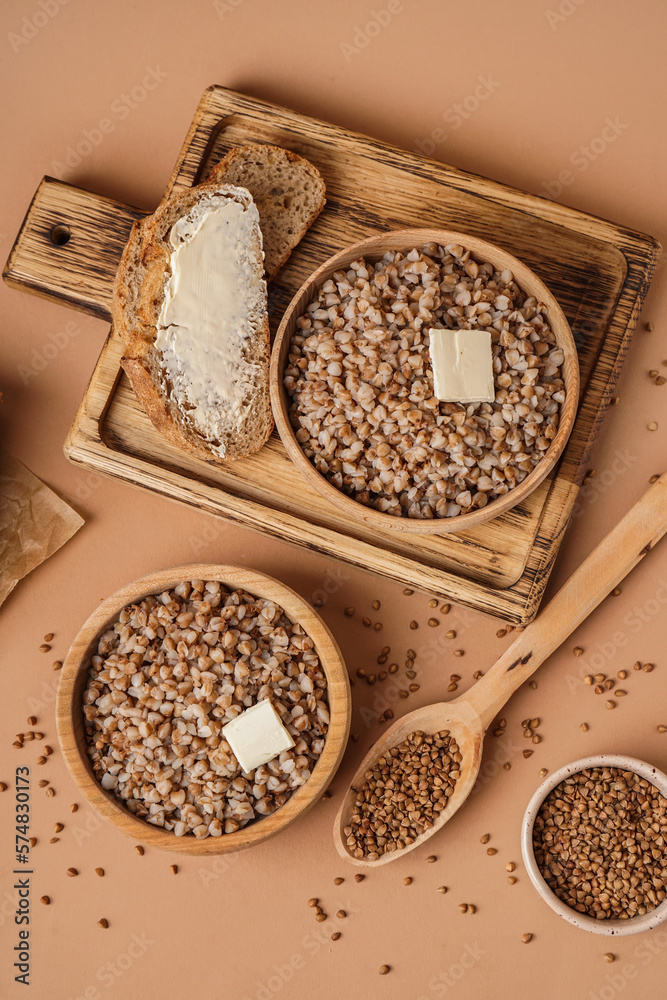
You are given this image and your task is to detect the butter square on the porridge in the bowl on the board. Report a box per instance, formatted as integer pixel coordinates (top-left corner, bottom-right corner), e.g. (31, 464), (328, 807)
(429, 330), (496, 403)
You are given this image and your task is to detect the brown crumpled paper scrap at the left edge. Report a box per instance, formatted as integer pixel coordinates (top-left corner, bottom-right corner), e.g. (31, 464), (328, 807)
(0, 450), (84, 604)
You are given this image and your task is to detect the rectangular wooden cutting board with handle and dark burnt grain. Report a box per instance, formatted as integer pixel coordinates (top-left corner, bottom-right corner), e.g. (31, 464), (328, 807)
(4, 87), (660, 624)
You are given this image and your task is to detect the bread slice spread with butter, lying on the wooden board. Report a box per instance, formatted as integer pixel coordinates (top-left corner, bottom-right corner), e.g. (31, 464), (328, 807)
(113, 180), (273, 462)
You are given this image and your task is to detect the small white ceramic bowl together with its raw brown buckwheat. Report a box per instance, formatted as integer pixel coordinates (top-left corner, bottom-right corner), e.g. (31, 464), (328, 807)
(521, 754), (667, 936)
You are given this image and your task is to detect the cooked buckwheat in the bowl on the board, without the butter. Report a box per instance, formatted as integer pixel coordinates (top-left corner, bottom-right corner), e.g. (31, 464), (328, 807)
(284, 243), (565, 518)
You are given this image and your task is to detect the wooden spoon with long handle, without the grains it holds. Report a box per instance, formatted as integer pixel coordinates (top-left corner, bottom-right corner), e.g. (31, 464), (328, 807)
(334, 473), (667, 867)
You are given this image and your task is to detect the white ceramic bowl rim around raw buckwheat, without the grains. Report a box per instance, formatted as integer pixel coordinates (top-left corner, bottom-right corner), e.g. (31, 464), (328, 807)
(521, 754), (667, 937)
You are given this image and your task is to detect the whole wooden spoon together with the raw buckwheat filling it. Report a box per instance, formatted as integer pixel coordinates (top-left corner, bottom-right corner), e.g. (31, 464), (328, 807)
(334, 474), (667, 867)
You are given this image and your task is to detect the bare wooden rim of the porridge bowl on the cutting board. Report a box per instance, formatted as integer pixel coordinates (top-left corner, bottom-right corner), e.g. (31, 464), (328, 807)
(270, 229), (579, 535)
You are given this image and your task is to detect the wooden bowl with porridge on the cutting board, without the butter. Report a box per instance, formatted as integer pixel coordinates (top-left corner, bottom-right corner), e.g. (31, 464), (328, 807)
(271, 229), (579, 534)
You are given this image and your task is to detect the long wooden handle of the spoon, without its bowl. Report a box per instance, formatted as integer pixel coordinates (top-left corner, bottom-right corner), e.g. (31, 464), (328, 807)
(461, 473), (667, 729)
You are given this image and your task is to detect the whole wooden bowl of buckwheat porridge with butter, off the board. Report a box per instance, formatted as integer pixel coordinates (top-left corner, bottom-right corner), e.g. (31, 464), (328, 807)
(56, 564), (351, 854)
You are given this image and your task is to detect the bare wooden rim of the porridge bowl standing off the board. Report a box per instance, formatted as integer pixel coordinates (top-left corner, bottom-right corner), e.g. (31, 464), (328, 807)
(56, 563), (351, 855)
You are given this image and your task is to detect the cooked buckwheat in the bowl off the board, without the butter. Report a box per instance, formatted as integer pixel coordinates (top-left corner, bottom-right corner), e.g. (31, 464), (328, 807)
(84, 580), (329, 837)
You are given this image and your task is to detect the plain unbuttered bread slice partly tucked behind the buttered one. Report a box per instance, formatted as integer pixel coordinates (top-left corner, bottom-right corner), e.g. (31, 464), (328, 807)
(209, 145), (326, 279)
